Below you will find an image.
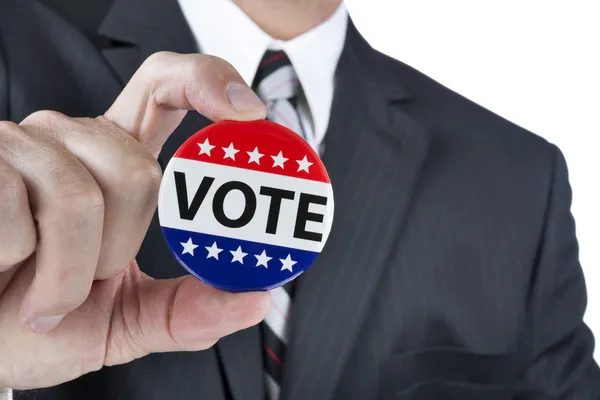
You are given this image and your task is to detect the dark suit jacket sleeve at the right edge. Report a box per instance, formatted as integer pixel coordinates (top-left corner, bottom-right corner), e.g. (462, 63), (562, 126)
(518, 147), (600, 400)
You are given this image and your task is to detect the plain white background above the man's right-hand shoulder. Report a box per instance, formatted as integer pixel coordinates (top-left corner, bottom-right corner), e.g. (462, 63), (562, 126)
(346, 0), (600, 361)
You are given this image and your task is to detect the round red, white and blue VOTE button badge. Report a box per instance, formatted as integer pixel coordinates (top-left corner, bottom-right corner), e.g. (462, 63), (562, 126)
(158, 121), (333, 292)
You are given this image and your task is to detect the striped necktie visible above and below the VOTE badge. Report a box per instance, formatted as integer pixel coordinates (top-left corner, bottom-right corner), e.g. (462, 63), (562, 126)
(253, 50), (307, 400)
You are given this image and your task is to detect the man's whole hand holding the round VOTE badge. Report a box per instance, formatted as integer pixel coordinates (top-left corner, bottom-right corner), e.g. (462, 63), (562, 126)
(0, 53), (270, 389)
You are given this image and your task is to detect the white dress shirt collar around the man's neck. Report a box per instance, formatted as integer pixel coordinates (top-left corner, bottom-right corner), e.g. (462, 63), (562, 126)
(179, 0), (348, 149)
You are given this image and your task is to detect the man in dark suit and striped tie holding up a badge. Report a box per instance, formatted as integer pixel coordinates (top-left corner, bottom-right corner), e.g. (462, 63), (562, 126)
(0, 0), (600, 400)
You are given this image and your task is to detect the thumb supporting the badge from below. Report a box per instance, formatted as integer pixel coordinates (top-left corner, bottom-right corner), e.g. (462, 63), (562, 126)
(105, 266), (271, 365)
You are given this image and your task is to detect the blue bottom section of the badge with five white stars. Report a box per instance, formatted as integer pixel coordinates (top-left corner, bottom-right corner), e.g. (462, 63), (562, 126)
(162, 227), (319, 292)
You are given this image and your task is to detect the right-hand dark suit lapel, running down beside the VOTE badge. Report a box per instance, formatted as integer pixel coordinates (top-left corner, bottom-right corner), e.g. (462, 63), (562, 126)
(281, 24), (429, 400)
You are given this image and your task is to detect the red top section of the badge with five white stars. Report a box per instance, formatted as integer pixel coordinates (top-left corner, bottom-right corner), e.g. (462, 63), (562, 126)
(174, 120), (330, 183)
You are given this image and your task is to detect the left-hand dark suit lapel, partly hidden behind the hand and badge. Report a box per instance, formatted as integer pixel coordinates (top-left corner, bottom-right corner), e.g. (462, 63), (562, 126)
(98, 0), (264, 400)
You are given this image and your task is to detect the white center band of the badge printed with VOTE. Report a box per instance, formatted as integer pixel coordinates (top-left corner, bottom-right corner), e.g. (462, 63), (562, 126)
(159, 158), (333, 252)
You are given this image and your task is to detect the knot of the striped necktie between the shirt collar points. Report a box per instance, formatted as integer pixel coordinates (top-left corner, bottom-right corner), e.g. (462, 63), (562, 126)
(253, 50), (300, 104)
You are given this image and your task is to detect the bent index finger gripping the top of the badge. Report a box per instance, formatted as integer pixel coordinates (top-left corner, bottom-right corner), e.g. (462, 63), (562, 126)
(104, 52), (267, 157)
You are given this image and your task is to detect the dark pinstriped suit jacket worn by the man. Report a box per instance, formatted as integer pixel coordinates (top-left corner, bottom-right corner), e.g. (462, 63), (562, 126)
(0, 0), (600, 400)
